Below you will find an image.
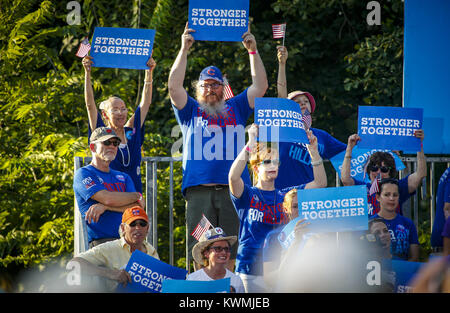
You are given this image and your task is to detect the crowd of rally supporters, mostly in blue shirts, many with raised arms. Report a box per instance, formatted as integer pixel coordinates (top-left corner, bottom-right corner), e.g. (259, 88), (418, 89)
(73, 24), (450, 293)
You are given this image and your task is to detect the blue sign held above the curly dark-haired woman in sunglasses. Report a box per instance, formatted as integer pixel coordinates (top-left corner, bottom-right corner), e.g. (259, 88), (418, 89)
(358, 106), (423, 151)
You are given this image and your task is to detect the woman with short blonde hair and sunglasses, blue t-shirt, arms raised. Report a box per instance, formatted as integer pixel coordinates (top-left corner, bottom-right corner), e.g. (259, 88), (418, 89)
(228, 124), (327, 292)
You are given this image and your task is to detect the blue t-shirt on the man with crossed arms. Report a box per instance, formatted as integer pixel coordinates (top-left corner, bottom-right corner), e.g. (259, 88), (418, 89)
(73, 164), (136, 242)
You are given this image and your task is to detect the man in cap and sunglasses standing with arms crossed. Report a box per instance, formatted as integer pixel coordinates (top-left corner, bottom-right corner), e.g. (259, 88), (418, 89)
(73, 127), (144, 248)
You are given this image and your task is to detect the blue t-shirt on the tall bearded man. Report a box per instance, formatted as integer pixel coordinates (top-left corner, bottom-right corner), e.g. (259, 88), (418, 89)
(172, 89), (253, 195)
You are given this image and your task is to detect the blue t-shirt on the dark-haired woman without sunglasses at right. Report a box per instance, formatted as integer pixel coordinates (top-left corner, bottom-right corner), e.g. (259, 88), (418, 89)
(373, 214), (419, 261)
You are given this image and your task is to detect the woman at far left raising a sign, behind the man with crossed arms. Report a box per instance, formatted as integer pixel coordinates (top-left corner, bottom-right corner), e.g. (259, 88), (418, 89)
(82, 56), (156, 193)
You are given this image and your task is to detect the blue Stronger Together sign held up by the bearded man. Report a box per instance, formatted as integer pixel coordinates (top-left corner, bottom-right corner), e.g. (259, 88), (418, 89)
(189, 0), (250, 41)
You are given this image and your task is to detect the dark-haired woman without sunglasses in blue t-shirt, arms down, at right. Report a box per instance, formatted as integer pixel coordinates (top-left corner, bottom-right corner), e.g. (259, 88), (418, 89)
(374, 178), (420, 262)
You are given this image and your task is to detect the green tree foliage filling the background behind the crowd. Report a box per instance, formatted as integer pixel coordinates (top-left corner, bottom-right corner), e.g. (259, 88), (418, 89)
(0, 0), (434, 288)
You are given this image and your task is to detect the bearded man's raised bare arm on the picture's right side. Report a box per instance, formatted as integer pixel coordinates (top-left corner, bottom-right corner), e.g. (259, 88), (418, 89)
(242, 26), (269, 109)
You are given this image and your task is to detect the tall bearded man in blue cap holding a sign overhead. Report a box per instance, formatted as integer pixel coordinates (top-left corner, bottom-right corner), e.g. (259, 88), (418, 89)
(169, 24), (268, 269)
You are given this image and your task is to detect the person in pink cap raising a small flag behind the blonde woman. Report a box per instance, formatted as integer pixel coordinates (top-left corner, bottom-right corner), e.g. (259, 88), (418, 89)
(275, 45), (346, 189)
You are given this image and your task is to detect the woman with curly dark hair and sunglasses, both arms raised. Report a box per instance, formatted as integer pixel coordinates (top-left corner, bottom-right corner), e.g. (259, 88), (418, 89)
(341, 129), (427, 217)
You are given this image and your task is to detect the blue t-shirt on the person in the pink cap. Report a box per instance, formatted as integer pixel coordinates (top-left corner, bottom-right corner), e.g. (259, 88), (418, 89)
(275, 128), (347, 189)
